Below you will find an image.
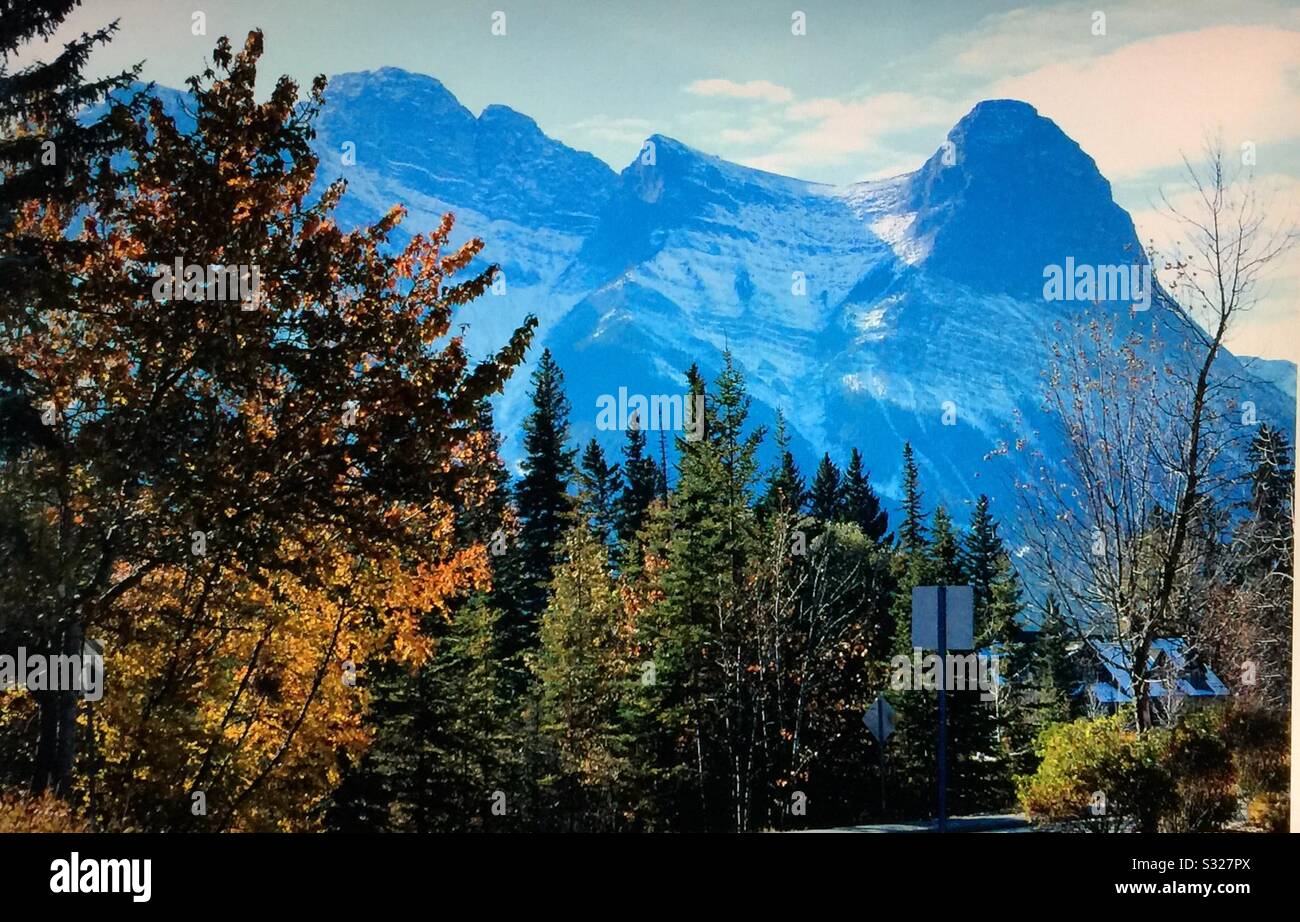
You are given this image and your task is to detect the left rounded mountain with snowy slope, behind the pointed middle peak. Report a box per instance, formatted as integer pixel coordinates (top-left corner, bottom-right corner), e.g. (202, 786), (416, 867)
(316, 68), (616, 354)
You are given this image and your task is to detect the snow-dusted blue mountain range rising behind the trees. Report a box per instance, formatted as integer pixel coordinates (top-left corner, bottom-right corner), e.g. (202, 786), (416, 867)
(304, 69), (1294, 515)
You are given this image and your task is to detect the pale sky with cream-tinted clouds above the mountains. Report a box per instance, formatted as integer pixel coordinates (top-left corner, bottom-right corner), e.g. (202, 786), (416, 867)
(20, 0), (1300, 360)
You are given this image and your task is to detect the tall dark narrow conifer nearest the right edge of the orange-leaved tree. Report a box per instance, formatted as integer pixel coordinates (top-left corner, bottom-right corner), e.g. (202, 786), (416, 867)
(502, 350), (577, 657)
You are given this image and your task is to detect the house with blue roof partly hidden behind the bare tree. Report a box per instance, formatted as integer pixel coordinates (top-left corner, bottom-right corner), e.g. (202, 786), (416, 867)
(1074, 637), (1232, 715)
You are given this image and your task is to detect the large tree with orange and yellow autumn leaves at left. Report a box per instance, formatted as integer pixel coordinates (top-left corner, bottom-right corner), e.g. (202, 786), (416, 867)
(0, 33), (534, 830)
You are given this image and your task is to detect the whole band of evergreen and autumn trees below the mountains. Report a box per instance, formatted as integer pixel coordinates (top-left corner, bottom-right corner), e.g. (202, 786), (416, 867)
(0, 0), (1294, 832)
